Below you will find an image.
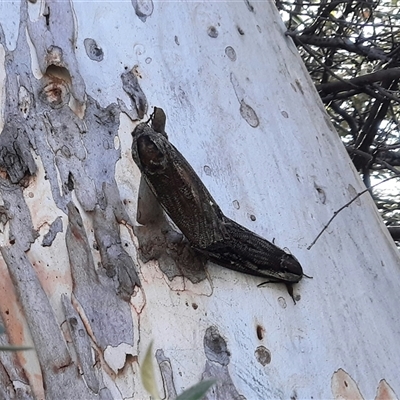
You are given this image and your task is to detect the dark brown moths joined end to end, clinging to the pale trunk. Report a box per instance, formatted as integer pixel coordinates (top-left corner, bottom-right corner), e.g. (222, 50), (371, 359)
(132, 108), (305, 297)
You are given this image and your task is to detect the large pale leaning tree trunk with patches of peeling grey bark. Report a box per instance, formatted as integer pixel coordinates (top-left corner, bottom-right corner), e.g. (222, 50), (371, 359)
(0, 0), (400, 400)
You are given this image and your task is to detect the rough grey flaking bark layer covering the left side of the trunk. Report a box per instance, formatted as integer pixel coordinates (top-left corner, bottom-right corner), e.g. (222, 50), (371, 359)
(0, 1), (143, 399)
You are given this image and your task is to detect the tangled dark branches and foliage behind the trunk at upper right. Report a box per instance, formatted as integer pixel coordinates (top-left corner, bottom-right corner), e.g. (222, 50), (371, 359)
(276, 0), (400, 240)
